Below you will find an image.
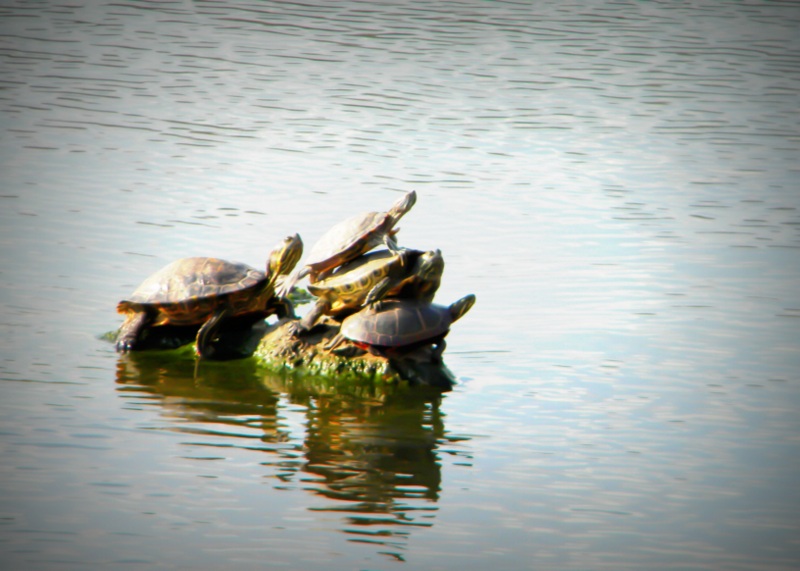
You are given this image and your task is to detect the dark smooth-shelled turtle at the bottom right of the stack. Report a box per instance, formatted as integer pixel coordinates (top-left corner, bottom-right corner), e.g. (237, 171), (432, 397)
(328, 294), (475, 359)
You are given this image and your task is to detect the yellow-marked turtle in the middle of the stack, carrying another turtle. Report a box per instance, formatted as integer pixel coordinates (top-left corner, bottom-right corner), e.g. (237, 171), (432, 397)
(297, 249), (444, 331)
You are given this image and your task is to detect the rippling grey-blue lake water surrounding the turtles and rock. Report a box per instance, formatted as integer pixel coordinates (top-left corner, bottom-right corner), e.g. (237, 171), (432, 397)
(0, 0), (800, 571)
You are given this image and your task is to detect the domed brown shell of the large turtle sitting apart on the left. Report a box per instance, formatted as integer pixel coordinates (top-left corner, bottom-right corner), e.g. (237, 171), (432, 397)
(117, 257), (271, 325)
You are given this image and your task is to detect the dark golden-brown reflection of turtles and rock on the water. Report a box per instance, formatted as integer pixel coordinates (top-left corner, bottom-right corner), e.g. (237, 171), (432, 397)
(116, 349), (465, 560)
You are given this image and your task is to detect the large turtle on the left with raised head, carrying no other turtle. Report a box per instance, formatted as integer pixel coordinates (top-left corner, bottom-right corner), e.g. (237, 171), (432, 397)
(116, 234), (303, 356)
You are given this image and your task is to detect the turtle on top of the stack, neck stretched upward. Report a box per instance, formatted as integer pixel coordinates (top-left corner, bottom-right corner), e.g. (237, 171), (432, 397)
(278, 190), (417, 297)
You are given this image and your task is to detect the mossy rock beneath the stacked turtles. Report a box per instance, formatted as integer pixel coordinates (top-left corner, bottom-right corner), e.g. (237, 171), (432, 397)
(255, 320), (455, 390)
